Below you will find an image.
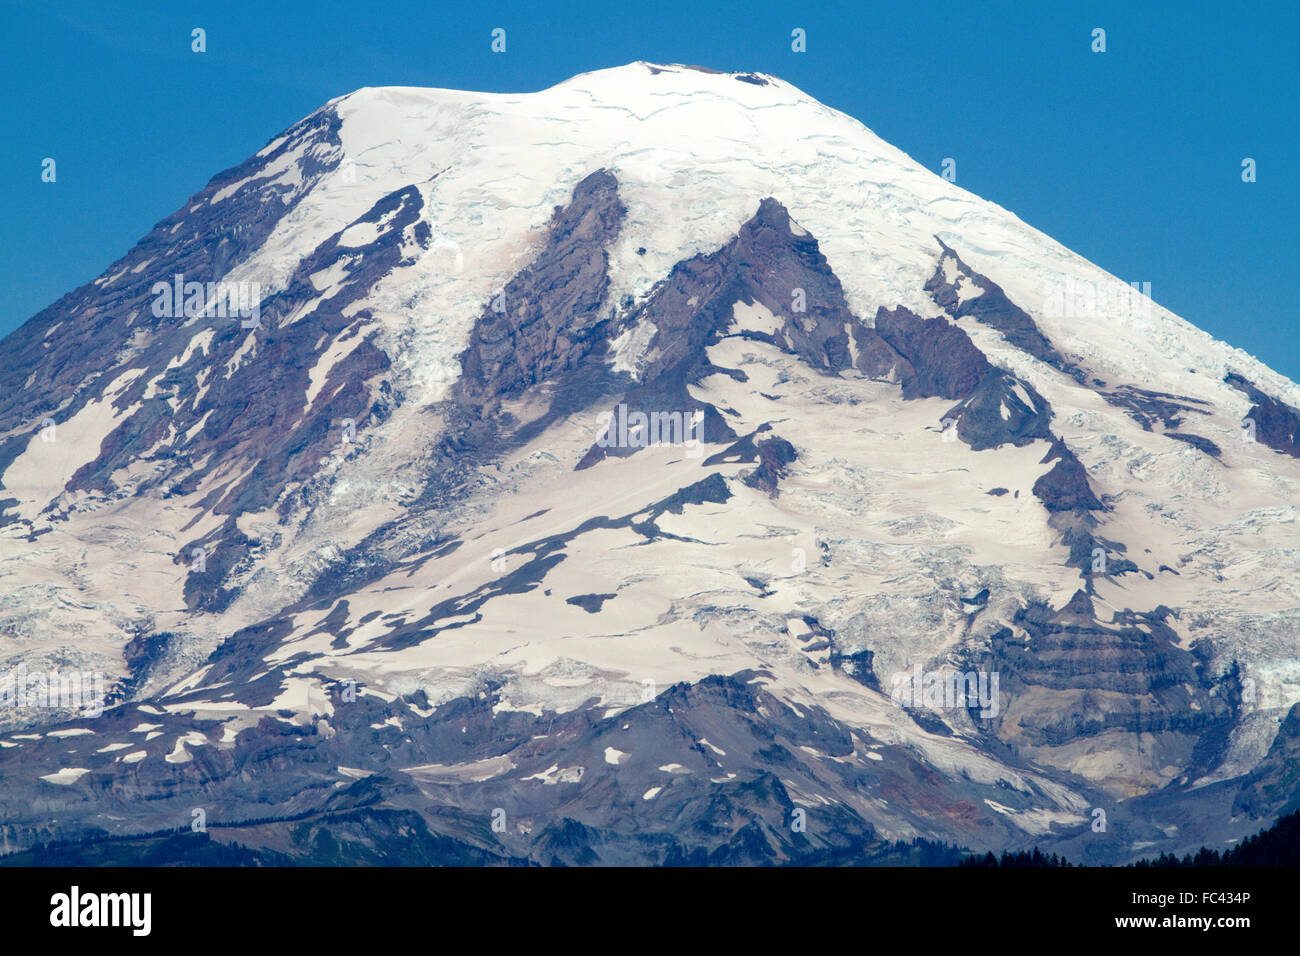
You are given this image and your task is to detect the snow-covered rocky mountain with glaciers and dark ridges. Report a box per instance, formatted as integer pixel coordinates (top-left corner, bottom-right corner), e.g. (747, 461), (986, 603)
(0, 62), (1300, 865)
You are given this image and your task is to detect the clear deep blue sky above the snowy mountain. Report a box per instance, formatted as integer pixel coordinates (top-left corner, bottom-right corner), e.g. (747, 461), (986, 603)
(0, 0), (1300, 380)
